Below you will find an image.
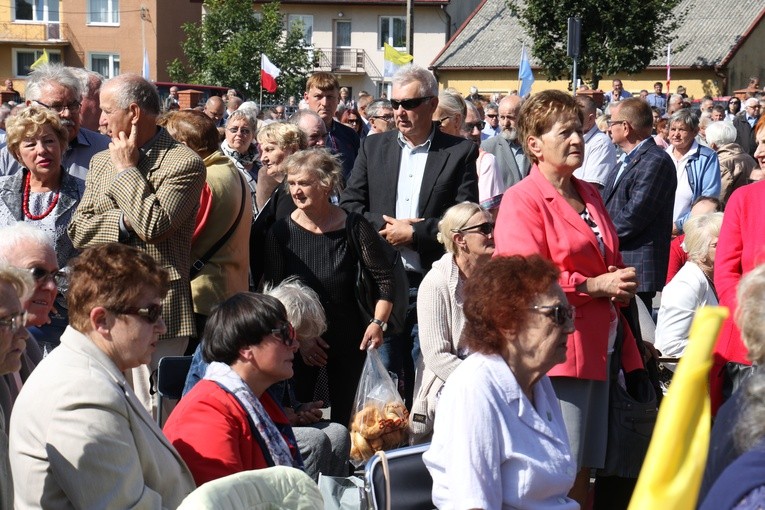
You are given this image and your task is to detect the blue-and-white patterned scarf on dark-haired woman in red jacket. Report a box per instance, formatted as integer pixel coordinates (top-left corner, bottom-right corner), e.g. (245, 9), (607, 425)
(204, 361), (303, 469)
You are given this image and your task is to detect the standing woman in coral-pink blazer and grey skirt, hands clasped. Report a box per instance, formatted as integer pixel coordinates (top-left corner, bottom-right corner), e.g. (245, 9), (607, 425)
(494, 90), (643, 506)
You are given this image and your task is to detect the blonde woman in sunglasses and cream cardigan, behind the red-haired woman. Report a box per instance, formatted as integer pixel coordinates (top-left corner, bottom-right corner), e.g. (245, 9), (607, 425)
(409, 202), (494, 443)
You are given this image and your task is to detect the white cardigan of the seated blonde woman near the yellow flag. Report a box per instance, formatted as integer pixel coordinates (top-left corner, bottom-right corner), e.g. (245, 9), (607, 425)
(654, 261), (717, 357)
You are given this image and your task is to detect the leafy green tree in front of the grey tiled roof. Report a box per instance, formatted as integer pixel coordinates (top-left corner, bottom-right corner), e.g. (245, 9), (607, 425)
(507, 0), (691, 87)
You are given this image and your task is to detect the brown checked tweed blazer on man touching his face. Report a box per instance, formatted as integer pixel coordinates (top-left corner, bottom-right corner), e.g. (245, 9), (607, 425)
(69, 129), (206, 339)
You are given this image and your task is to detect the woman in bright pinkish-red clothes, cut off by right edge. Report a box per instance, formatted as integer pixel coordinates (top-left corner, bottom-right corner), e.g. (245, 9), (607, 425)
(710, 116), (765, 413)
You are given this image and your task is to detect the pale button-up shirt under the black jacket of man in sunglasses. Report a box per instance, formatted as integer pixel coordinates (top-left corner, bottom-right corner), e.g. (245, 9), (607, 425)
(396, 131), (435, 273)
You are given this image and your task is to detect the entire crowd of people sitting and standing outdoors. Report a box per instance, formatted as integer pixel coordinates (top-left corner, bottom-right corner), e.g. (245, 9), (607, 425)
(0, 60), (765, 509)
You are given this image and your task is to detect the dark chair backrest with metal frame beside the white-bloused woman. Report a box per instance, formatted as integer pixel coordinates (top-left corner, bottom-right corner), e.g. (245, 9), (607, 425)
(364, 443), (433, 510)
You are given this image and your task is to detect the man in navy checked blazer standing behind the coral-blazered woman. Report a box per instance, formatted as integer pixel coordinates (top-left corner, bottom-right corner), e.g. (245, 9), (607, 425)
(603, 98), (677, 310)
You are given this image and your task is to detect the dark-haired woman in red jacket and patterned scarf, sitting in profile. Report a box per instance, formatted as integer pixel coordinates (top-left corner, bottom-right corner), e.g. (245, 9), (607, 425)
(164, 292), (303, 485)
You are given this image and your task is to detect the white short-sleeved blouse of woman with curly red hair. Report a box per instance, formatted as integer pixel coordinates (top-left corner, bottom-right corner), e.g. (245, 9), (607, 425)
(423, 353), (579, 510)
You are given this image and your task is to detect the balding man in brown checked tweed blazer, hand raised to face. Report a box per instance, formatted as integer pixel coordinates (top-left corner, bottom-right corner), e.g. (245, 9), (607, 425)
(69, 74), (206, 417)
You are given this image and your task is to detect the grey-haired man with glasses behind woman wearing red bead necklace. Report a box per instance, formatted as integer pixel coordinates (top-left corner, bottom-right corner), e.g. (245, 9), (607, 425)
(0, 64), (109, 181)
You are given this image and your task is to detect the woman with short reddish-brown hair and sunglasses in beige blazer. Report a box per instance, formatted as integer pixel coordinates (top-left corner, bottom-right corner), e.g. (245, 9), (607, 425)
(10, 243), (194, 508)
